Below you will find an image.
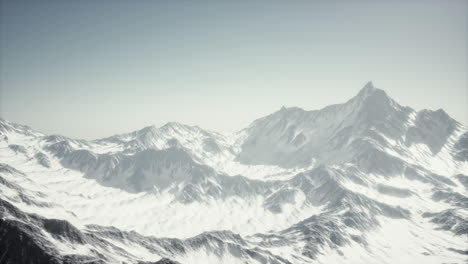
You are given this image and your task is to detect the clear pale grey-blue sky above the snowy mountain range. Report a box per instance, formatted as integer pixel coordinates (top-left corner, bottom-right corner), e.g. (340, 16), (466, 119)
(0, 0), (468, 139)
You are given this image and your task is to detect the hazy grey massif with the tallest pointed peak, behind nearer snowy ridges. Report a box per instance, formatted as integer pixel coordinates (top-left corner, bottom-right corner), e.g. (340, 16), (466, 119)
(238, 83), (464, 167)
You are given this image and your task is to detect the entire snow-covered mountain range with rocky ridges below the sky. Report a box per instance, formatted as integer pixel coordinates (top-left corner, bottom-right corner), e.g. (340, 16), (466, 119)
(0, 83), (468, 264)
